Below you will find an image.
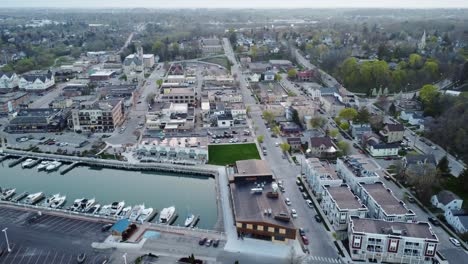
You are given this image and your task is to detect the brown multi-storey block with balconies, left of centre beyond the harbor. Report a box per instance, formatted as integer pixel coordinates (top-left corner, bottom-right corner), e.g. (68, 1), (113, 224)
(69, 100), (124, 132)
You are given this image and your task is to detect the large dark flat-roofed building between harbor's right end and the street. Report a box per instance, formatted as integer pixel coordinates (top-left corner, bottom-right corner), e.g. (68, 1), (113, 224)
(229, 160), (297, 243)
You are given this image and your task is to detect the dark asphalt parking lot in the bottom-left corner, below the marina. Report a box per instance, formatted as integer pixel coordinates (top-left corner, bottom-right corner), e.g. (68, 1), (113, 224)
(0, 206), (112, 264)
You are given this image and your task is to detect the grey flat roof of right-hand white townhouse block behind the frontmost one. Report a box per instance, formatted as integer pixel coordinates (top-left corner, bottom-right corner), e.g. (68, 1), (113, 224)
(361, 183), (413, 215)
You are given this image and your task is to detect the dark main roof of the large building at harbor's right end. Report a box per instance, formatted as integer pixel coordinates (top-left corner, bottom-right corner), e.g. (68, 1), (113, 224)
(230, 181), (294, 228)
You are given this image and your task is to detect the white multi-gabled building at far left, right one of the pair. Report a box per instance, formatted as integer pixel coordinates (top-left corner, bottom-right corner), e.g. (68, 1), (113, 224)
(18, 71), (55, 91)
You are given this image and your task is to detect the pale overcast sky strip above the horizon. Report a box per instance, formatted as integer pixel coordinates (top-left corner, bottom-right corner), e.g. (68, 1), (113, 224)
(0, 0), (468, 8)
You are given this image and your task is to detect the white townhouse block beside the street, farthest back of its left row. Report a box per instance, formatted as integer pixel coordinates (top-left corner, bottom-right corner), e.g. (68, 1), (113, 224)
(303, 158), (343, 198)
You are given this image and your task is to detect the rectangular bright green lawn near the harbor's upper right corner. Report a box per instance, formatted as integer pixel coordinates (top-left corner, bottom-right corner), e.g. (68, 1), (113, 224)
(208, 143), (260, 165)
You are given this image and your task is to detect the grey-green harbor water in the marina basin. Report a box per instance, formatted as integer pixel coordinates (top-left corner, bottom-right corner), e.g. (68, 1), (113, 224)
(0, 160), (217, 229)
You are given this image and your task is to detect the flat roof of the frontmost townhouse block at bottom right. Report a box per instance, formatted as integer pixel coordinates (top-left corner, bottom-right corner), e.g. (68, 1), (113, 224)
(351, 217), (438, 240)
